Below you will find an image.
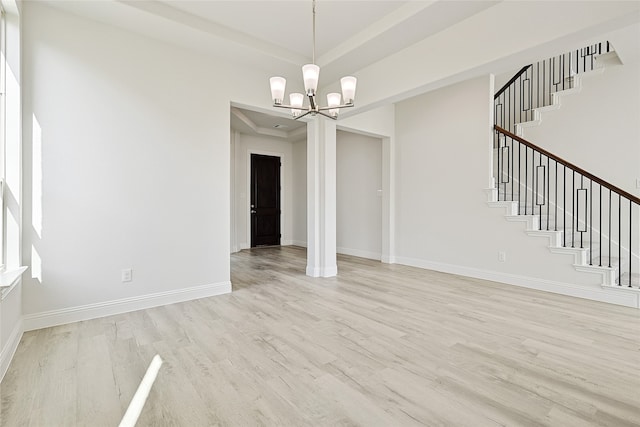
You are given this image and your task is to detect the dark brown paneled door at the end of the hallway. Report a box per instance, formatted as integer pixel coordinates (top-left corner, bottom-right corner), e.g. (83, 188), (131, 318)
(251, 154), (280, 248)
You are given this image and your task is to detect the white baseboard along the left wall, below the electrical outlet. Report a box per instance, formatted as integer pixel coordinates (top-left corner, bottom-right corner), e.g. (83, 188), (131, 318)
(22, 281), (231, 331)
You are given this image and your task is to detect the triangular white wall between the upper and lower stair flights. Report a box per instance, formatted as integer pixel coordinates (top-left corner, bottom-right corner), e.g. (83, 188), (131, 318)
(523, 61), (640, 196)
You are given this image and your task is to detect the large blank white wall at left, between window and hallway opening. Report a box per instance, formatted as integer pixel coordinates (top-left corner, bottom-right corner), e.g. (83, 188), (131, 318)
(23, 2), (282, 328)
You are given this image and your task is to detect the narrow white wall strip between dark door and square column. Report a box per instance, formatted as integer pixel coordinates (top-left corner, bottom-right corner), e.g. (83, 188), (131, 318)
(291, 140), (307, 247)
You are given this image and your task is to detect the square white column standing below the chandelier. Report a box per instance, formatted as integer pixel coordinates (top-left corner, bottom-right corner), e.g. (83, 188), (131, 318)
(307, 116), (338, 277)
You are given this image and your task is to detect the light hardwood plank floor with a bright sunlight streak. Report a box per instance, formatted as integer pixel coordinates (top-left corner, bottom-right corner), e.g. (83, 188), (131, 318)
(1, 247), (640, 427)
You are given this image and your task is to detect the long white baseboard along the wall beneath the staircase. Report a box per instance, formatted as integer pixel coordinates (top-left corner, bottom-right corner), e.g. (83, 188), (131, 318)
(396, 257), (640, 308)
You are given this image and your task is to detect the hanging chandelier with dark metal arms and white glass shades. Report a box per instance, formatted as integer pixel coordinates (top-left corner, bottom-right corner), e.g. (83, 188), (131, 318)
(269, 0), (357, 120)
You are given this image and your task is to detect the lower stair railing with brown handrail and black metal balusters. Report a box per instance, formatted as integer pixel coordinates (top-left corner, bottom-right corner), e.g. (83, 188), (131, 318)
(494, 125), (640, 287)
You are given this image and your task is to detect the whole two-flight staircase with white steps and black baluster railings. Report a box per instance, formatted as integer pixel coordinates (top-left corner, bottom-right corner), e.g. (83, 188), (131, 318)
(487, 42), (640, 308)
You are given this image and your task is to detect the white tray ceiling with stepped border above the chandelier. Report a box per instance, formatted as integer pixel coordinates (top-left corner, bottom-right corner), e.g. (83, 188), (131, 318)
(44, 0), (500, 82)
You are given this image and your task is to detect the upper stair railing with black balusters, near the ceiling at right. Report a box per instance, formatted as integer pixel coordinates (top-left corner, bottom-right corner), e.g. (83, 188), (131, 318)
(494, 42), (613, 132)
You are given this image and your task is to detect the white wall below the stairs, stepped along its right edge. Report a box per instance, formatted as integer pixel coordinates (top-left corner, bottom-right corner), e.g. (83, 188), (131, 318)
(396, 77), (616, 298)
